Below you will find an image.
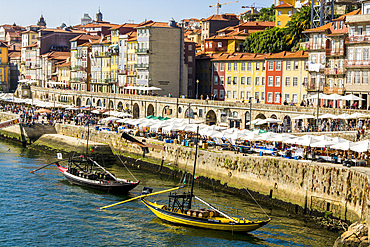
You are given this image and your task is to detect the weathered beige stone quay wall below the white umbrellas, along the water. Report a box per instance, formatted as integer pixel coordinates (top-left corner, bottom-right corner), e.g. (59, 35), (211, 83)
(56, 124), (370, 225)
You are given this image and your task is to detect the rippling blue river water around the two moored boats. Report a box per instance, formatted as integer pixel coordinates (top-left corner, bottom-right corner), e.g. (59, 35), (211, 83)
(0, 140), (338, 246)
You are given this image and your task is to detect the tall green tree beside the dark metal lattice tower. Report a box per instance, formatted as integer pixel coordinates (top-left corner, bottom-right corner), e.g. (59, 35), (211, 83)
(285, 6), (311, 47)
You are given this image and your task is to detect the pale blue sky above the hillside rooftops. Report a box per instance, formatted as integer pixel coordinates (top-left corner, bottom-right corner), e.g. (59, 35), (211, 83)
(0, 0), (274, 27)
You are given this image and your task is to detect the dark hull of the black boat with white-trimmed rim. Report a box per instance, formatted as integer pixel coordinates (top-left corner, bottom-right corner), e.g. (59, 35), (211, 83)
(58, 166), (140, 194)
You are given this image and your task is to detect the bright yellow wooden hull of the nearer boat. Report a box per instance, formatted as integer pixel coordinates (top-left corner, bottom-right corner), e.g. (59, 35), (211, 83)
(141, 199), (270, 232)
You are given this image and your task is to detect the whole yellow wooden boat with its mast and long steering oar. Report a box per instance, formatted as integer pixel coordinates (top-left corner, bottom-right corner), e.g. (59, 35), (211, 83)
(101, 126), (271, 232)
